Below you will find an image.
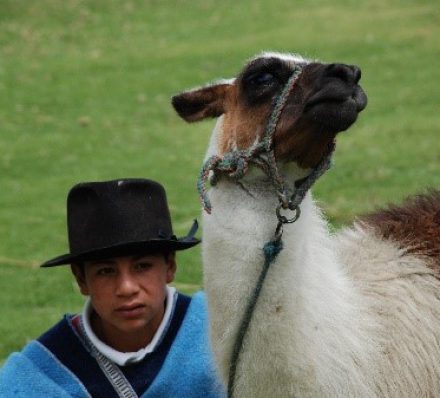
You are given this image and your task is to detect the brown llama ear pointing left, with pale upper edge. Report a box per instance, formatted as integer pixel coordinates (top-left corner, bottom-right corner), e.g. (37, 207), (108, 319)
(171, 82), (232, 122)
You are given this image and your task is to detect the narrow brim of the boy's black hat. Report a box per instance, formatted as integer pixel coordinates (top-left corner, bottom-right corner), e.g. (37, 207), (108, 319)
(40, 237), (200, 268)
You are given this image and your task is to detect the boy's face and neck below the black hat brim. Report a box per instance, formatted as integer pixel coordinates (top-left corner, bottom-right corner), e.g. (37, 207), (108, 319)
(72, 254), (176, 351)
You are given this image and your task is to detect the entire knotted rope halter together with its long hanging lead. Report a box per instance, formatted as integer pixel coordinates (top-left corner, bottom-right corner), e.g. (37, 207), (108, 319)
(197, 65), (334, 398)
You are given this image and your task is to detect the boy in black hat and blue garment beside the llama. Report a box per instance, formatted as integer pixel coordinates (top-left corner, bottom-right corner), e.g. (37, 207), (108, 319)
(0, 179), (224, 398)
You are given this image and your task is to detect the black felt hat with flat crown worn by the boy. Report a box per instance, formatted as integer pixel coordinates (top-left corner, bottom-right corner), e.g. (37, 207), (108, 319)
(41, 178), (200, 267)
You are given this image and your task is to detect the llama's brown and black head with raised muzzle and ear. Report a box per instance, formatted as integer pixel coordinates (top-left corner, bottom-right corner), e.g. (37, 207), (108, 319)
(172, 53), (367, 168)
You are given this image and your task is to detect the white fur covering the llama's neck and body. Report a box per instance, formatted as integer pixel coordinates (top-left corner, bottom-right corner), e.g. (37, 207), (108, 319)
(174, 53), (440, 398)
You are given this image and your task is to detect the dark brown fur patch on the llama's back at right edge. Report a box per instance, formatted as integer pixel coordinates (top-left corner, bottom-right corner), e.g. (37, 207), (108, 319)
(361, 190), (440, 276)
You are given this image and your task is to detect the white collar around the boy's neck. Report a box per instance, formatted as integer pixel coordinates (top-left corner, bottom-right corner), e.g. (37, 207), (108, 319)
(81, 286), (177, 366)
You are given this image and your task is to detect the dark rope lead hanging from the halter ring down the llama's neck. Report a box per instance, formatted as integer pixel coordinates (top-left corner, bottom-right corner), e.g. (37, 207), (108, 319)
(228, 238), (283, 398)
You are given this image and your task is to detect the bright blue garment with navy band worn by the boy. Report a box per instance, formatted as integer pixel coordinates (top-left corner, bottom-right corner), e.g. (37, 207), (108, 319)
(0, 293), (226, 398)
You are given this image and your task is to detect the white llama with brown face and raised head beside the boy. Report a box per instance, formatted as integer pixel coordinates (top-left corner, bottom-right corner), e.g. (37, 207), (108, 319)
(173, 53), (440, 398)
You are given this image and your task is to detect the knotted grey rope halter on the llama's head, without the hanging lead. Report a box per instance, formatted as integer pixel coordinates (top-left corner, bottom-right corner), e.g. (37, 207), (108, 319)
(197, 64), (334, 230)
